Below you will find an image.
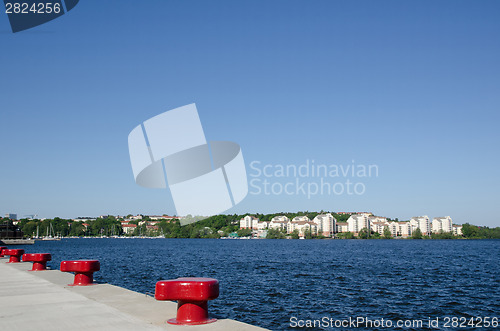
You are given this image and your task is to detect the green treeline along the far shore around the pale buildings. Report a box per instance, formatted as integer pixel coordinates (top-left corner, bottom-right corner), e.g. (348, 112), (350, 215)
(0, 211), (500, 239)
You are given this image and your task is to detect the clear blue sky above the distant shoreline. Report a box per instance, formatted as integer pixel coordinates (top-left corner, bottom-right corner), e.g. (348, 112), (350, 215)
(0, 0), (500, 226)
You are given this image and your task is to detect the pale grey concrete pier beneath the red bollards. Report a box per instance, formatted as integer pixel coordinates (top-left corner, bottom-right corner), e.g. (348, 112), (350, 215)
(0, 258), (265, 331)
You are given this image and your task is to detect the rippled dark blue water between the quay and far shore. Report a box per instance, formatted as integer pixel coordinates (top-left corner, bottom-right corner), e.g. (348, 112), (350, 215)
(13, 239), (500, 330)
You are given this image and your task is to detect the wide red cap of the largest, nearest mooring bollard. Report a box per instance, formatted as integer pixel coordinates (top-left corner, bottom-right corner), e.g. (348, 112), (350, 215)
(155, 277), (219, 301)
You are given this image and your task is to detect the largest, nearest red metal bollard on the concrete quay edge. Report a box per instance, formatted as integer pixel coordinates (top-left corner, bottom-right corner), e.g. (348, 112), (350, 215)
(155, 277), (219, 325)
